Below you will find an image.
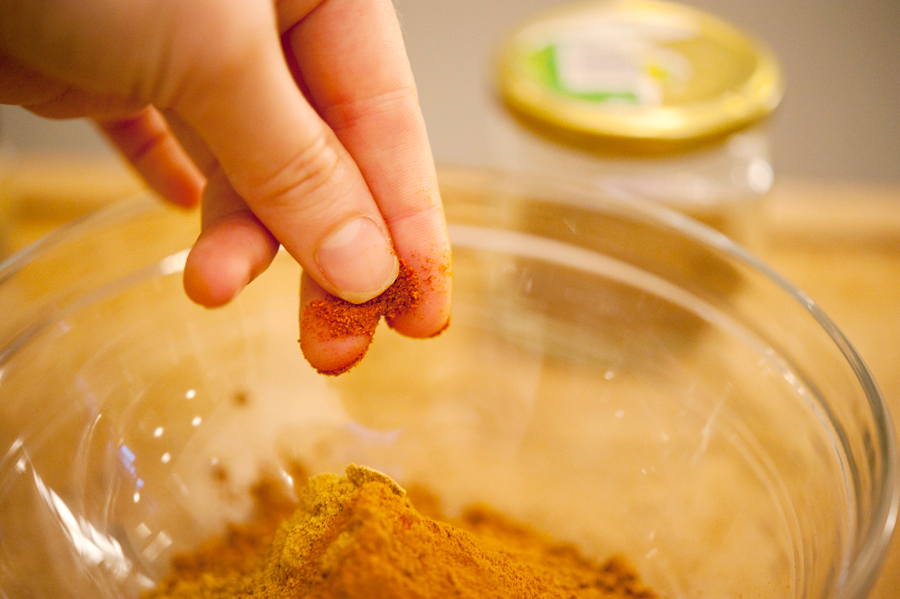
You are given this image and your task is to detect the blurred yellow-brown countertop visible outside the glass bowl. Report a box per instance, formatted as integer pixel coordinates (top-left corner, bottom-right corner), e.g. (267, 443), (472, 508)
(0, 161), (900, 599)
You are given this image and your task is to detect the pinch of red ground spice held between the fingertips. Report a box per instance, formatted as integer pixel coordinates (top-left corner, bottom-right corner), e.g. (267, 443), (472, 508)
(302, 261), (421, 375)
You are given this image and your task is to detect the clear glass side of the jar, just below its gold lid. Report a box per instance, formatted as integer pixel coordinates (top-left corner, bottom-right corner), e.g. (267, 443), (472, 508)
(487, 105), (775, 247)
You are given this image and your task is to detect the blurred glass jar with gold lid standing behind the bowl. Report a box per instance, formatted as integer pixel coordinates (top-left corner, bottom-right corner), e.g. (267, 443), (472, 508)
(489, 0), (784, 242)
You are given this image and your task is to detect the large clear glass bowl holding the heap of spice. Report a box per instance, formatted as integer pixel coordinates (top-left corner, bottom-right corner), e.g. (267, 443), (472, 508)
(0, 170), (898, 599)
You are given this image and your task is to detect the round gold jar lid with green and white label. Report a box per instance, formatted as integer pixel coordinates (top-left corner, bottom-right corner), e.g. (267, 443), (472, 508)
(498, 0), (784, 152)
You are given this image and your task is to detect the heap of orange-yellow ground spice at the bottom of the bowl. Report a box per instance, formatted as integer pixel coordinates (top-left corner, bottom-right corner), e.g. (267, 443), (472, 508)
(144, 465), (657, 599)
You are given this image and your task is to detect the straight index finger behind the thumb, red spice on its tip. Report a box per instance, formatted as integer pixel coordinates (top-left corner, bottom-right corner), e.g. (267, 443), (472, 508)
(279, 0), (451, 337)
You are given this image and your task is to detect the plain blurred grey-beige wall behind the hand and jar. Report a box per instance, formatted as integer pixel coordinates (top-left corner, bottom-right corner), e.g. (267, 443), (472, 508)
(0, 0), (900, 184)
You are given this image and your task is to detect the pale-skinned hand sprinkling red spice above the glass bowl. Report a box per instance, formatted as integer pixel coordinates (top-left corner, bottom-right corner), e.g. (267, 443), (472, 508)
(0, 0), (450, 370)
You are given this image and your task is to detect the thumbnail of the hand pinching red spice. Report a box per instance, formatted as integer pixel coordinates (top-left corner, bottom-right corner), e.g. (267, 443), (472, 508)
(316, 217), (400, 303)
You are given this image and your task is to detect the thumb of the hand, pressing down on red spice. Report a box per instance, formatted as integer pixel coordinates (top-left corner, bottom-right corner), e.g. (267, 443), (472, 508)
(173, 8), (399, 303)
